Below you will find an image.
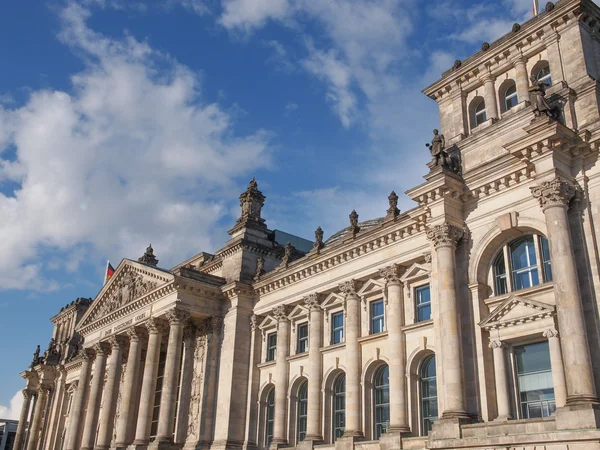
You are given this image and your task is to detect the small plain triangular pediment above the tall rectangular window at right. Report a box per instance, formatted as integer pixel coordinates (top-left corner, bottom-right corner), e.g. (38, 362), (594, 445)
(479, 295), (556, 330)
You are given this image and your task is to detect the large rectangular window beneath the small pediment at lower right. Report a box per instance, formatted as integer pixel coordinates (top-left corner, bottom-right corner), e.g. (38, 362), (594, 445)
(514, 341), (556, 419)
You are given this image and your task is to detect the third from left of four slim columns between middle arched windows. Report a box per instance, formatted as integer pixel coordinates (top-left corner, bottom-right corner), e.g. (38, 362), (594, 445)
(340, 280), (362, 436)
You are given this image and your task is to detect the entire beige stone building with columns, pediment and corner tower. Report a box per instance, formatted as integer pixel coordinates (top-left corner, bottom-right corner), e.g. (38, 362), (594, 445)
(15, 0), (600, 450)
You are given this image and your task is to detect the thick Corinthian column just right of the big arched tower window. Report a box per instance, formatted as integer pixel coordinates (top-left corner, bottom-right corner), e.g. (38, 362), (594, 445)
(531, 177), (598, 405)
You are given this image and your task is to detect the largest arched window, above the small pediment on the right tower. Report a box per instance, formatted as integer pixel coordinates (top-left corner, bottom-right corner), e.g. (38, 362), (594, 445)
(493, 235), (552, 295)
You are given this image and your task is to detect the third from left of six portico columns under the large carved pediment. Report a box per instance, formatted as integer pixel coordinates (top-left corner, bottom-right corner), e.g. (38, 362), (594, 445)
(95, 335), (125, 450)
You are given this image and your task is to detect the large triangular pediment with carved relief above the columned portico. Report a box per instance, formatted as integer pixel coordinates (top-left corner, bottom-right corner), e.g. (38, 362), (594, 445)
(78, 259), (174, 328)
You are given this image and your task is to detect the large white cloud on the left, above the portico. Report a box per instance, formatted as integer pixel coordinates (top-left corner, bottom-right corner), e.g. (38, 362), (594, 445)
(0, 3), (269, 289)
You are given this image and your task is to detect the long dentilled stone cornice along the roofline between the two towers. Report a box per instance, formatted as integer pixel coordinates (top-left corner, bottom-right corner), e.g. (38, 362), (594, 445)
(253, 212), (427, 295)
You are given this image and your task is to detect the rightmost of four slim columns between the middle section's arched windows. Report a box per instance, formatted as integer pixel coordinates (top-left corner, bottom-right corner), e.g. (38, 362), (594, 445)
(379, 264), (410, 433)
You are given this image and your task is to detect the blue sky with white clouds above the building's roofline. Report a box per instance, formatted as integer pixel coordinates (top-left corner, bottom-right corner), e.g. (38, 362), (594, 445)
(0, 0), (531, 417)
